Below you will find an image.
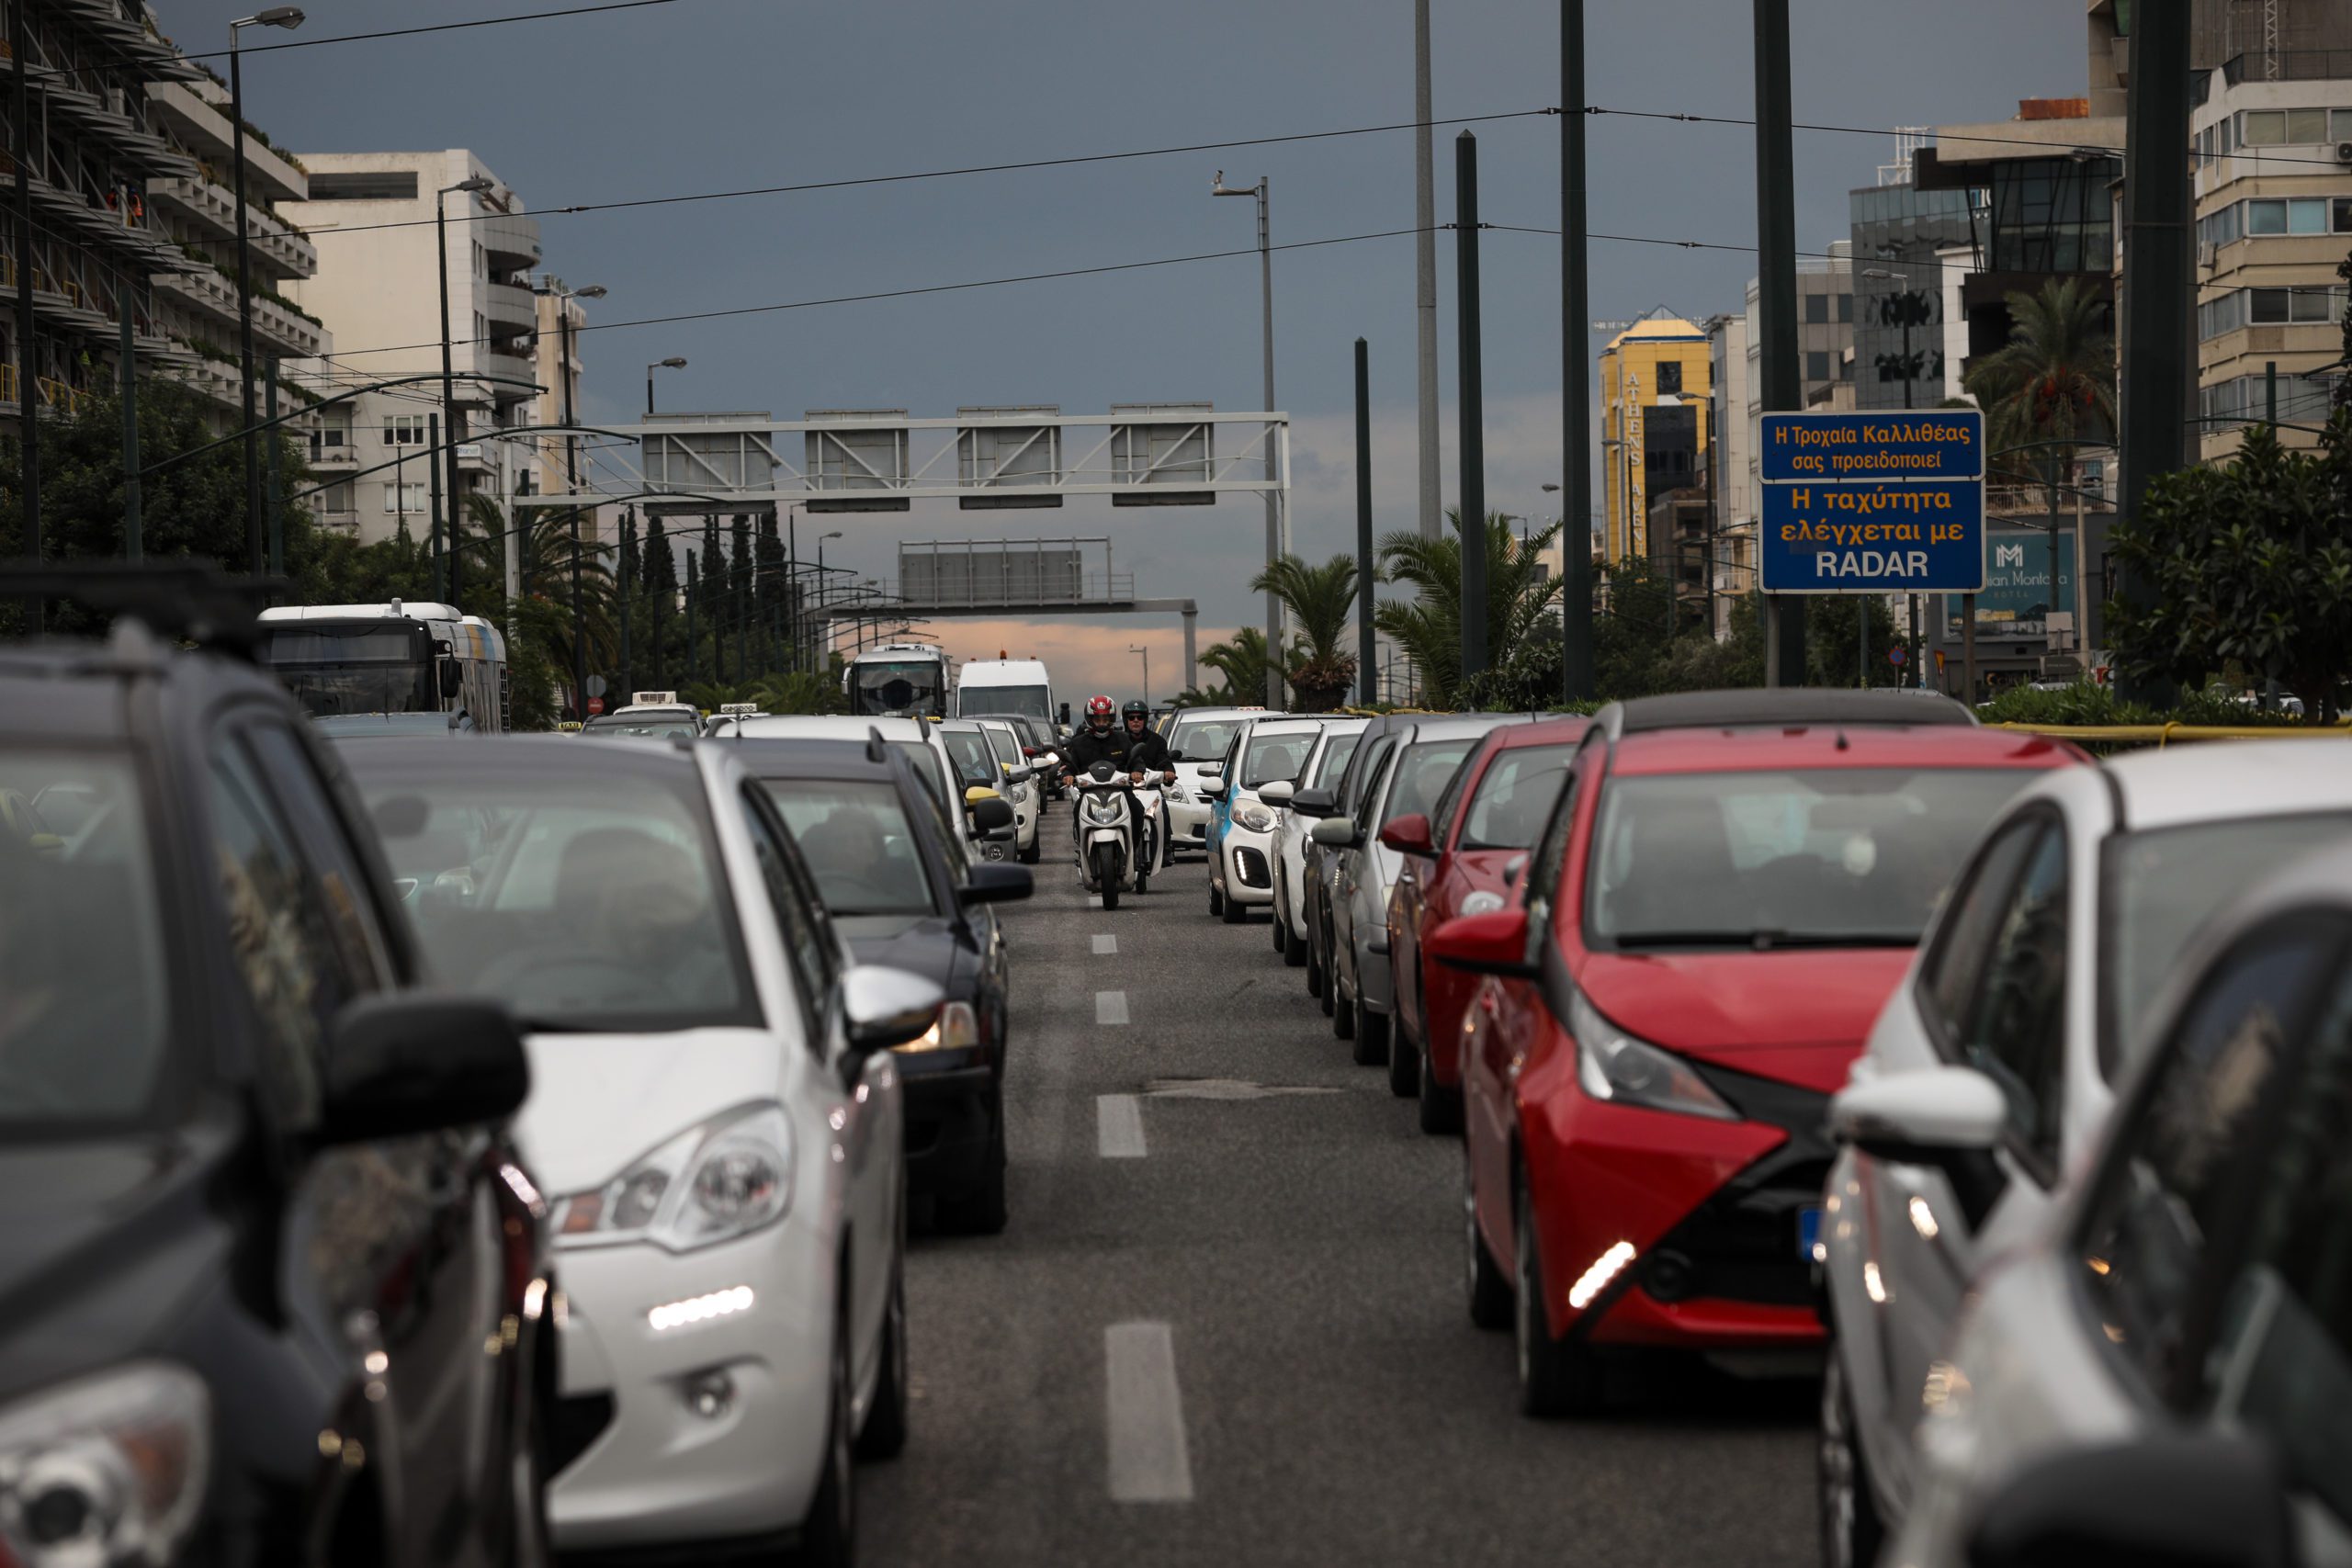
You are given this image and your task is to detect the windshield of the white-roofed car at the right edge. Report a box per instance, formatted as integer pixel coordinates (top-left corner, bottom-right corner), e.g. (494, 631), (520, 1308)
(2100, 811), (2352, 1077)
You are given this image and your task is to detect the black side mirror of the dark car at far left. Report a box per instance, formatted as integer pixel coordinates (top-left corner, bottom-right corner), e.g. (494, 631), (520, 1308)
(320, 992), (532, 1145)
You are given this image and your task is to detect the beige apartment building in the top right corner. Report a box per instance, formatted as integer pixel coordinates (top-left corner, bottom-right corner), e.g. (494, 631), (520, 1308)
(2189, 50), (2352, 463)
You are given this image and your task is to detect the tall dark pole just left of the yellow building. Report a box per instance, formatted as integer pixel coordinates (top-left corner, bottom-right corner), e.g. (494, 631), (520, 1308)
(1559, 0), (1599, 703)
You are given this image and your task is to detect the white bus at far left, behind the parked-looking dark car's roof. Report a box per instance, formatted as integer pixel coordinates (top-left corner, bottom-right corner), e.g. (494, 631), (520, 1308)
(261, 600), (513, 733)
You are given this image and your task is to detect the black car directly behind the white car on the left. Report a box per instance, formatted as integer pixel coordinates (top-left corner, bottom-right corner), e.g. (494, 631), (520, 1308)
(729, 740), (1030, 1235)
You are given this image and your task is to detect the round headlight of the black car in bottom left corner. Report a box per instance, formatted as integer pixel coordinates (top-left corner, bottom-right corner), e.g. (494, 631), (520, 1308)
(0, 1361), (211, 1568)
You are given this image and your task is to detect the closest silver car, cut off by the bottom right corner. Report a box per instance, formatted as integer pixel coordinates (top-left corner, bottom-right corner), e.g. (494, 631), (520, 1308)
(1862, 841), (2352, 1568)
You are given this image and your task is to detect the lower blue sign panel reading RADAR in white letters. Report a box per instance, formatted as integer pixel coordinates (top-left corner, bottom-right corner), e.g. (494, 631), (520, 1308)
(1761, 479), (1985, 592)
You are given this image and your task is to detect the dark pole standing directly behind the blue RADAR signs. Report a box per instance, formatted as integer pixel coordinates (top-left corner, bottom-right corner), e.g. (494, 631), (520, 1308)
(1749, 0), (1796, 686)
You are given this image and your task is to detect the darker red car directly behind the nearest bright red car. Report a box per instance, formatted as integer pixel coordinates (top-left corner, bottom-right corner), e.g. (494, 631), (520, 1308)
(1381, 717), (1592, 1134)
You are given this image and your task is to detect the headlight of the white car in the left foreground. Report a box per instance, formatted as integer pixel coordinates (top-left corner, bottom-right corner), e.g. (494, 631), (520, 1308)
(555, 1105), (793, 1253)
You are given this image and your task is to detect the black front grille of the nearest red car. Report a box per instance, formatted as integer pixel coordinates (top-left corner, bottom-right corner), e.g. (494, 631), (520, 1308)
(1637, 1063), (1832, 1307)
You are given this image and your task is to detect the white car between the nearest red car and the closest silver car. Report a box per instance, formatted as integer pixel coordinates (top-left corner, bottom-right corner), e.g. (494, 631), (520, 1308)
(1814, 740), (2352, 1568)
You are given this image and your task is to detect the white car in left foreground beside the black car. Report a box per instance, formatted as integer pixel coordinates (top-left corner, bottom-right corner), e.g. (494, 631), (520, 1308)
(350, 740), (944, 1563)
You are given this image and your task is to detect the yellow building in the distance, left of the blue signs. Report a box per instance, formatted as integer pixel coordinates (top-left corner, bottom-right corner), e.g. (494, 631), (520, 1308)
(1600, 315), (1714, 562)
